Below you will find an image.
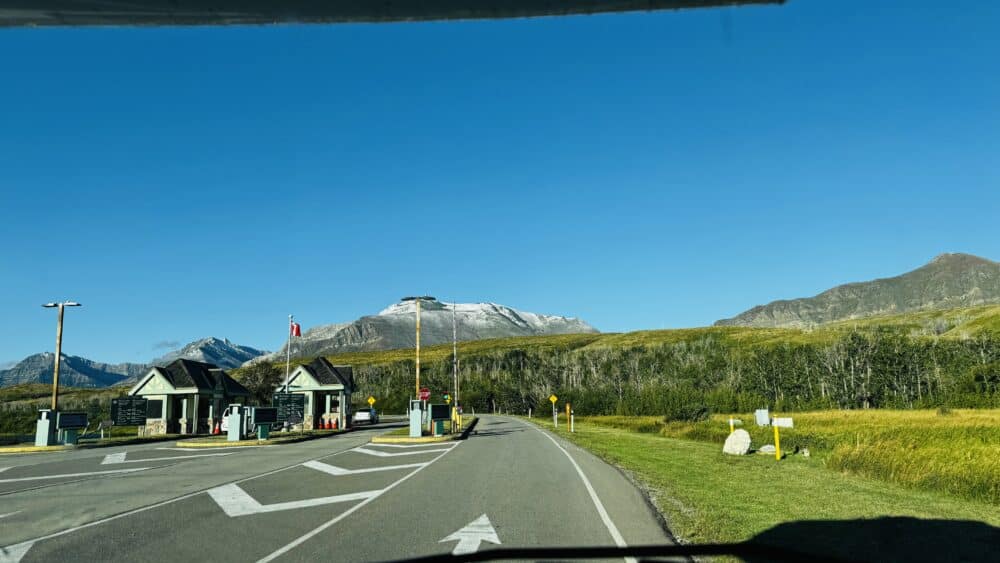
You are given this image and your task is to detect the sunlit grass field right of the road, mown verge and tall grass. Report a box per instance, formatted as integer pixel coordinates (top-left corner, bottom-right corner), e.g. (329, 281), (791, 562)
(534, 411), (1000, 556)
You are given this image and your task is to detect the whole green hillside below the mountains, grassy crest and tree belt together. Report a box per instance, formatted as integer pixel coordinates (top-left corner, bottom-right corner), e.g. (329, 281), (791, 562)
(229, 306), (1000, 415)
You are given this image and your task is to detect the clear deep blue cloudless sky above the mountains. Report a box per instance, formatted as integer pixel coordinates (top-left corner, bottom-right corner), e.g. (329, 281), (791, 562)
(0, 0), (1000, 361)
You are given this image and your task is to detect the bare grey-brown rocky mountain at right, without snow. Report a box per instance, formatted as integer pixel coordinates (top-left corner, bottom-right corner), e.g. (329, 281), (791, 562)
(715, 254), (1000, 328)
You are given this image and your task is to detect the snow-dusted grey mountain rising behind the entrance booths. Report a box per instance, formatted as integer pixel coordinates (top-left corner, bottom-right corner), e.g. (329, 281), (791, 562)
(249, 301), (598, 361)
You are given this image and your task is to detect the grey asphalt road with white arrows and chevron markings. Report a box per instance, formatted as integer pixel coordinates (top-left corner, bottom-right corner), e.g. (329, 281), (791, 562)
(0, 416), (669, 562)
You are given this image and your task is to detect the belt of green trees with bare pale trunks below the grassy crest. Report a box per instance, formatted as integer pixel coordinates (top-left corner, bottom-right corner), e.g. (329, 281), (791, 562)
(354, 328), (1000, 415)
